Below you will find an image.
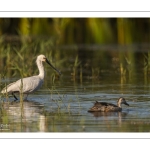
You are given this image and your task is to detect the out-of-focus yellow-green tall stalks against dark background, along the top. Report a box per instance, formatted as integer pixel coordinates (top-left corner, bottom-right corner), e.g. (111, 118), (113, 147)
(0, 18), (150, 45)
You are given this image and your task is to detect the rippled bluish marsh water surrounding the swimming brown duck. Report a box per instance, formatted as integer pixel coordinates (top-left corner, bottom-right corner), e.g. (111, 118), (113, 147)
(1, 77), (150, 132)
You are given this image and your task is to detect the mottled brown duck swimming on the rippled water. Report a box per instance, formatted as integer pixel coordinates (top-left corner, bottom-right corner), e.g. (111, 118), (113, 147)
(88, 97), (129, 112)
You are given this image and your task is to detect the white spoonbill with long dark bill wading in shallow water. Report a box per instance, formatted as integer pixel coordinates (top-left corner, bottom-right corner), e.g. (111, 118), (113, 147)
(1, 55), (61, 100)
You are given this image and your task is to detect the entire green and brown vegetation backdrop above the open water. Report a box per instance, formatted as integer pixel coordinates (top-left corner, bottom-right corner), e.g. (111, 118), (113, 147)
(0, 18), (150, 83)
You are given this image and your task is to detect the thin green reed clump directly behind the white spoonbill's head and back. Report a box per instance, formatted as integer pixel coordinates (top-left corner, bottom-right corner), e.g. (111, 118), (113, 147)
(0, 37), (61, 77)
